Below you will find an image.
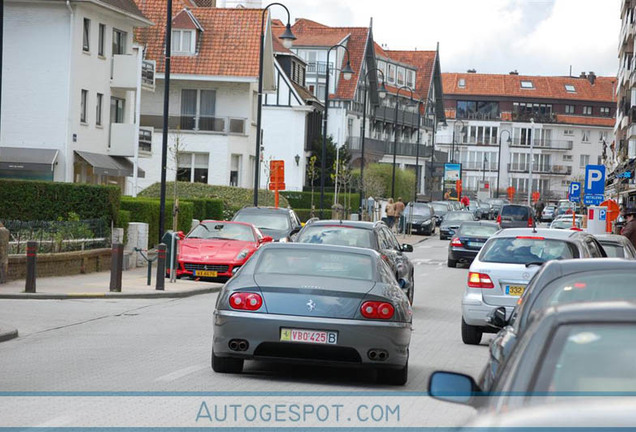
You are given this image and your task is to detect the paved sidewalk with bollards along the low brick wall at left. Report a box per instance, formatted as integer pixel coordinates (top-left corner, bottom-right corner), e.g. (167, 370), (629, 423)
(0, 267), (223, 300)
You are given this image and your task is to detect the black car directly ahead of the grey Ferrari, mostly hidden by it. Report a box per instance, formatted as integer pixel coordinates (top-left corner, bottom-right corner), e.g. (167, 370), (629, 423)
(295, 220), (415, 304)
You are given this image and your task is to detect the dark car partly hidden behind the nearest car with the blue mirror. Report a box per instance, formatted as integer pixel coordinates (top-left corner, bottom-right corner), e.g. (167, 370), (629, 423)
(479, 258), (636, 391)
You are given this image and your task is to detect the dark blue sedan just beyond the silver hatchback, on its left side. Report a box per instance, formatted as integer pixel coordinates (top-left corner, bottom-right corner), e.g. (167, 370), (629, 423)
(447, 221), (499, 267)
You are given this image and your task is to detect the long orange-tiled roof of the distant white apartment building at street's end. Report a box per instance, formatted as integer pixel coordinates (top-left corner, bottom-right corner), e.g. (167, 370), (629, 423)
(442, 73), (616, 102)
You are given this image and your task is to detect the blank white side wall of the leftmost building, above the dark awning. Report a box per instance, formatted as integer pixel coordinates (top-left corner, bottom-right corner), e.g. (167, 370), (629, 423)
(0, 1), (69, 181)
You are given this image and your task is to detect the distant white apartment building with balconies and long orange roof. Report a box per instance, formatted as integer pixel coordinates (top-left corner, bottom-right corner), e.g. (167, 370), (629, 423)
(437, 71), (616, 200)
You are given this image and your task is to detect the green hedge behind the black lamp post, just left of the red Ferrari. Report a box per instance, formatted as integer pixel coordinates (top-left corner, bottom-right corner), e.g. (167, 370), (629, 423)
(121, 197), (194, 247)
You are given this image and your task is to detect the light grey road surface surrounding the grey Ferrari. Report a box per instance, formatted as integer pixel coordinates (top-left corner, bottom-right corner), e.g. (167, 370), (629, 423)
(0, 236), (490, 426)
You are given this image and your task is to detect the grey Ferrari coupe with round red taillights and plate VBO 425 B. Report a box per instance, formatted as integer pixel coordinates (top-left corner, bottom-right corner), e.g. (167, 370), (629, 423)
(212, 243), (412, 385)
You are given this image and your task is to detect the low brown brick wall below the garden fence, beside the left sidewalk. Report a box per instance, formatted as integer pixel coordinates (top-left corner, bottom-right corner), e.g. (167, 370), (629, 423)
(7, 249), (111, 281)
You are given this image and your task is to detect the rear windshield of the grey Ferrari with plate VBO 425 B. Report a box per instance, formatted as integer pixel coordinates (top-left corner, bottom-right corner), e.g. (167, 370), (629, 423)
(256, 247), (373, 280)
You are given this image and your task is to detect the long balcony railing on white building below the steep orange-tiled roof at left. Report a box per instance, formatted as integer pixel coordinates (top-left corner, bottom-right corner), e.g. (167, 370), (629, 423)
(141, 115), (247, 135)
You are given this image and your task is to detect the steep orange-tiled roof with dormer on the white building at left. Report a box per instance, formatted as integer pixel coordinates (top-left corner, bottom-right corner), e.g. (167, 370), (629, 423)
(136, 0), (263, 77)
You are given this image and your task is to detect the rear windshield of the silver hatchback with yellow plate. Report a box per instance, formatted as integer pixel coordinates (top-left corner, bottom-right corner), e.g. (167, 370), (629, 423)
(479, 237), (579, 264)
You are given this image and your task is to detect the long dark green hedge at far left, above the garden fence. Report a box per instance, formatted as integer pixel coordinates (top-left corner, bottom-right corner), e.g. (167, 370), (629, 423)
(0, 179), (120, 223)
